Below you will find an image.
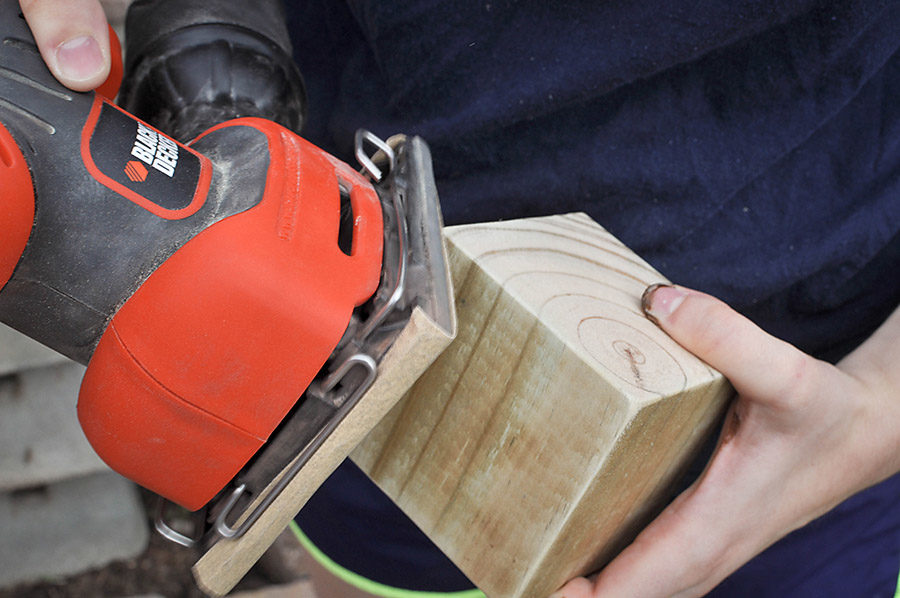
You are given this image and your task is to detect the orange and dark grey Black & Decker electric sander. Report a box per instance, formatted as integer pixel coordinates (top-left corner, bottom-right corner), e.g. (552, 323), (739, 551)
(0, 0), (453, 543)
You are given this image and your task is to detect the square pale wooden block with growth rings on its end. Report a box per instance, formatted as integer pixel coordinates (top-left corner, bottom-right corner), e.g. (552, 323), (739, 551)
(353, 215), (731, 598)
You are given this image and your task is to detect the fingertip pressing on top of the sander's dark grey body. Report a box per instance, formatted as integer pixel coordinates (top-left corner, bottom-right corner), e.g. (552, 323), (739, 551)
(19, 0), (110, 91)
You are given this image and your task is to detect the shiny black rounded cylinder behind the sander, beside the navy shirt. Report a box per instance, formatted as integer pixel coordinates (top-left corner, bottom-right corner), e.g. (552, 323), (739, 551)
(119, 0), (306, 141)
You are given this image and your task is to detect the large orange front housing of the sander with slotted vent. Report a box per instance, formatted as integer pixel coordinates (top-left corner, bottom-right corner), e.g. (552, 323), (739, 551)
(78, 118), (383, 510)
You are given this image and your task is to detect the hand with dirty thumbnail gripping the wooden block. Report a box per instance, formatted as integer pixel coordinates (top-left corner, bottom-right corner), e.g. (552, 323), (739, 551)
(554, 286), (900, 598)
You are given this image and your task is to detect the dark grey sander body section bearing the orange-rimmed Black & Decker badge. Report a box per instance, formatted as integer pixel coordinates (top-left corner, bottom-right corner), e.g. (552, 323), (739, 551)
(0, 0), (243, 363)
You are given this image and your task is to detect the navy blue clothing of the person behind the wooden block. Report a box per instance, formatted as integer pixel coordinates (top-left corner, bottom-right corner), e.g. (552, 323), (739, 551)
(288, 0), (900, 596)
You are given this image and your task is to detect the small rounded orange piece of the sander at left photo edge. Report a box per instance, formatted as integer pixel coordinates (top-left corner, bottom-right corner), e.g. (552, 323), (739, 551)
(0, 124), (34, 289)
